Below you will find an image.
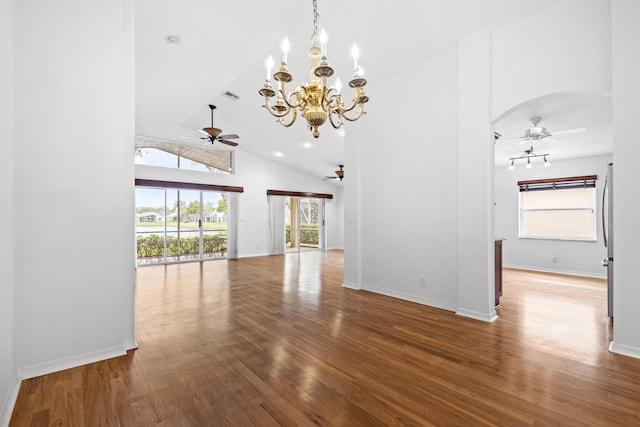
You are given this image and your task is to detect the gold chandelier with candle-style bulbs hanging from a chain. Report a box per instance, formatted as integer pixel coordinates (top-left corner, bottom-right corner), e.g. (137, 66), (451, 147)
(259, 0), (369, 138)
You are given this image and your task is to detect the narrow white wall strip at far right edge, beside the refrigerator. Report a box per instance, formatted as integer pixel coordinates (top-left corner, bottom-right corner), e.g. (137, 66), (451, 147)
(610, 0), (640, 358)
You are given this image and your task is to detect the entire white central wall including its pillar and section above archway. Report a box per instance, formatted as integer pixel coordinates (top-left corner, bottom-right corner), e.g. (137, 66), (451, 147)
(345, 0), (611, 320)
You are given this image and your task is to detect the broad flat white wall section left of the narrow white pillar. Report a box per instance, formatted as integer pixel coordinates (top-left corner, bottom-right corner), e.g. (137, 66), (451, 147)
(356, 49), (458, 310)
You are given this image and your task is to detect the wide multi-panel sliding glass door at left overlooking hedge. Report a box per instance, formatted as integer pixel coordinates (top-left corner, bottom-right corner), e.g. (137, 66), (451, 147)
(136, 187), (229, 265)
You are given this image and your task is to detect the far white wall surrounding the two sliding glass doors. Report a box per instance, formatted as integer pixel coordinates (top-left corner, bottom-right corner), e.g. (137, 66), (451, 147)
(136, 150), (344, 258)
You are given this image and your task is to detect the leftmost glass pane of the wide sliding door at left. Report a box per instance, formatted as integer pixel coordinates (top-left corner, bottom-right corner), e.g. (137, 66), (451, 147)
(136, 187), (165, 265)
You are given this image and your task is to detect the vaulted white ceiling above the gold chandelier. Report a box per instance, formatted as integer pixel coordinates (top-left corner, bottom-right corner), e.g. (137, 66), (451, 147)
(135, 0), (610, 179)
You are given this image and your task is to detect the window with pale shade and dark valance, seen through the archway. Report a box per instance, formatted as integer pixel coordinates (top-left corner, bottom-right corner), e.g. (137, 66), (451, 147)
(518, 175), (597, 241)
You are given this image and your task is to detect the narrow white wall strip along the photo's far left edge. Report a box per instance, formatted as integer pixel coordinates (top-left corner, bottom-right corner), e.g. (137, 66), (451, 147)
(0, 0), (17, 425)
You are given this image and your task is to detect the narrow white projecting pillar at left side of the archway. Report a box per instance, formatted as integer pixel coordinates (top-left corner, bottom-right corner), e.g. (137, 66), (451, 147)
(456, 30), (496, 322)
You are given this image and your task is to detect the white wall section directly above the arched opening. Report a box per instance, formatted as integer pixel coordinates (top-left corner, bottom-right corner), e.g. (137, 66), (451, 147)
(492, 0), (611, 118)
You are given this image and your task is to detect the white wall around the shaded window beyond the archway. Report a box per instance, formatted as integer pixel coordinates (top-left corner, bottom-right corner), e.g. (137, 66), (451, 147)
(495, 155), (612, 277)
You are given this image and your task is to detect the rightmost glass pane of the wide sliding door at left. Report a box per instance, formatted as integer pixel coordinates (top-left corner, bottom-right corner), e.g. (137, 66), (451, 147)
(202, 191), (229, 259)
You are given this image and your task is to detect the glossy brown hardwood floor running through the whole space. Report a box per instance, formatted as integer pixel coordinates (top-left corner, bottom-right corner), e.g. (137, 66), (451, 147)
(11, 252), (640, 426)
